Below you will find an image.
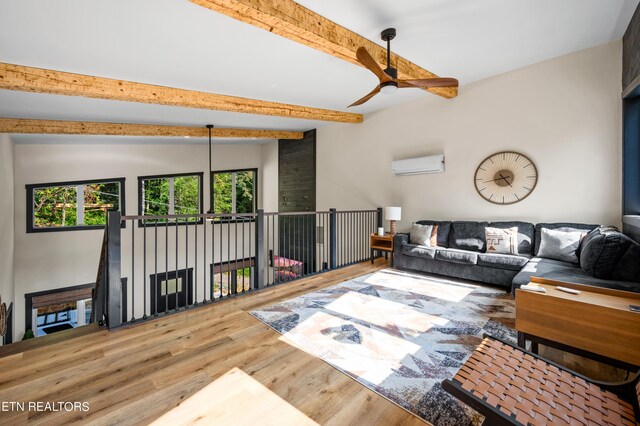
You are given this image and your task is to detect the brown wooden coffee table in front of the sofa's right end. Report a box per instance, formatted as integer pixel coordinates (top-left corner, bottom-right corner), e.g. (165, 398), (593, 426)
(516, 277), (640, 370)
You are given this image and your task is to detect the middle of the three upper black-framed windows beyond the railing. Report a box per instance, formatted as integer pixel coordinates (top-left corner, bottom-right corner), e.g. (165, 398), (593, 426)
(138, 173), (203, 225)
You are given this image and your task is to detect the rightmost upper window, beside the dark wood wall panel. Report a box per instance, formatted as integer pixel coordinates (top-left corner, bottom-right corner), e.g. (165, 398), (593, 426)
(212, 169), (258, 220)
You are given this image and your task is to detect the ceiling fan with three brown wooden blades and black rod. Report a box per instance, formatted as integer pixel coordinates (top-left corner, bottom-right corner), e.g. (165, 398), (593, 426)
(349, 28), (458, 108)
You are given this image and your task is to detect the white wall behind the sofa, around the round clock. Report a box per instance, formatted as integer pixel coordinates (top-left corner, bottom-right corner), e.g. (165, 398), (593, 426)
(317, 41), (622, 230)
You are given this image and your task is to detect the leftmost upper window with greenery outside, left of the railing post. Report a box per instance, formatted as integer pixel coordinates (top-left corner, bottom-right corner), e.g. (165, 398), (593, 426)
(27, 178), (125, 232)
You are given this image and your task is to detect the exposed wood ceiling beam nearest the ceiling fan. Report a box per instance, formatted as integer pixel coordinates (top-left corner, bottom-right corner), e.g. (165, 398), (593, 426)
(189, 0), (458, 98)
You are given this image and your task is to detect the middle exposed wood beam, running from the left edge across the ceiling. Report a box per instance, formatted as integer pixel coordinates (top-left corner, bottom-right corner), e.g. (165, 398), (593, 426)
(0, 62), (362, 123)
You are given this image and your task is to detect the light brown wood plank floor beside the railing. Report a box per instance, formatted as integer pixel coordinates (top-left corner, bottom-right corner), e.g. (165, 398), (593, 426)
(0, 259), (424, 425)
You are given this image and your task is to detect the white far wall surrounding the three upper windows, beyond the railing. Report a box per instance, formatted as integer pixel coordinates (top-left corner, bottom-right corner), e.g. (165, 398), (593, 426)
(12, 144), (268, 339)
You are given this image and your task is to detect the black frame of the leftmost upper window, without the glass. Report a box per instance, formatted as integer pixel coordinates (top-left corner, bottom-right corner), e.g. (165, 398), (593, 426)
(25, 177), (127, 234)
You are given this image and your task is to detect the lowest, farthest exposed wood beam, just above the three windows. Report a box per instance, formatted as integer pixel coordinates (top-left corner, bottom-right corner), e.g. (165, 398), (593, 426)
(0, 118), (304, 139)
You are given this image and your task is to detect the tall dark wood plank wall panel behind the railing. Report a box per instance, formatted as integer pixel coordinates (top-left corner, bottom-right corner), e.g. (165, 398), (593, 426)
(278, 130), (316, 273)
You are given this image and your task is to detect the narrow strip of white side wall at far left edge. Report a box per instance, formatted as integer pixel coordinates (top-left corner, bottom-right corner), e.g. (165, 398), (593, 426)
(0, 134), (15, 344)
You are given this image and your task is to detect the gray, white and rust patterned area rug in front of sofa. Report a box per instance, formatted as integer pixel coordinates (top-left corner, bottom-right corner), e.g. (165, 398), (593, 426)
(251, 269), (516, 426)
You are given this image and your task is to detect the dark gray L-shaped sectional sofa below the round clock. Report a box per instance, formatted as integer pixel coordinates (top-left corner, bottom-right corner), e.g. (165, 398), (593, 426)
(394, 220), (640, 292)
